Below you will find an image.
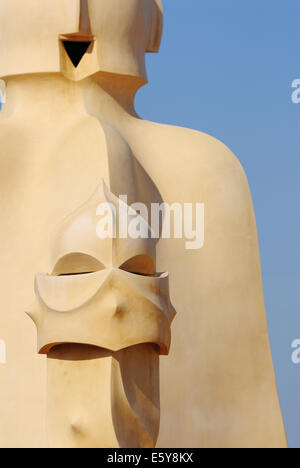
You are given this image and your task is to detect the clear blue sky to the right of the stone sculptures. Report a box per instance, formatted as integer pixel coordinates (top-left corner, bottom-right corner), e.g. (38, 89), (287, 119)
(136, 0), (300, 448)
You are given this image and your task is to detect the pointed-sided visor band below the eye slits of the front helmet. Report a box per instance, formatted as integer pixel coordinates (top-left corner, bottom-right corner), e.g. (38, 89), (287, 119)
(30, 269), (175, 354)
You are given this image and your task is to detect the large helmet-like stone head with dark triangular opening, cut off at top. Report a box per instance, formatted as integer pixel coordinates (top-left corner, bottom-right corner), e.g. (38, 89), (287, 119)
(0, 0), (162, 80)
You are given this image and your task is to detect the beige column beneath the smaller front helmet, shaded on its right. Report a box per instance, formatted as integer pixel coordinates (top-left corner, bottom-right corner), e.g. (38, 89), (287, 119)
(47, 344), (160, 448)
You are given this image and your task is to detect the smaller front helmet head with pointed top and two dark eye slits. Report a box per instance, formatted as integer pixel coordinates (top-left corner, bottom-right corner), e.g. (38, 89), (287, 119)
(30, 183), (175, 354)
